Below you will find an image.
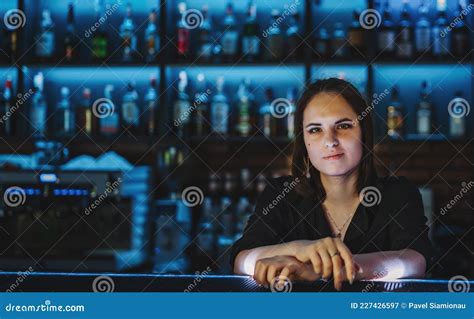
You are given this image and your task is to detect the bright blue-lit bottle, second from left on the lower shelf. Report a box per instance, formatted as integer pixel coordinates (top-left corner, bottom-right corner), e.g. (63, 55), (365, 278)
(30, 72), (48, 137)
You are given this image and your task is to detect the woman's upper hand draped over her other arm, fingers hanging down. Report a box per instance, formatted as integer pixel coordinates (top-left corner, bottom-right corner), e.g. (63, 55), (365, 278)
(295, 237), (356, 290)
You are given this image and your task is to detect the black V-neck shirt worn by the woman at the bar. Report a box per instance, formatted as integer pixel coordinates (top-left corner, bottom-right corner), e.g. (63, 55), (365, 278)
(230, 176), (432, 269)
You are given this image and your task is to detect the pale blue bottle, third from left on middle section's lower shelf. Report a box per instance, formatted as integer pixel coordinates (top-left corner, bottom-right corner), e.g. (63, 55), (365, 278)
(211, 76), (230, 136)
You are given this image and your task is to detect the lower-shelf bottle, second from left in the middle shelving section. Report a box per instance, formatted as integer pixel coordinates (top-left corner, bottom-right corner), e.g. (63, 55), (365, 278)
(192, 73), (210, 136)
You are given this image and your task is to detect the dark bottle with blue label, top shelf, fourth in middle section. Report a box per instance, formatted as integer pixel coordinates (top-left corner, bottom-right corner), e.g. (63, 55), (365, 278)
(242, 1), (260, 62)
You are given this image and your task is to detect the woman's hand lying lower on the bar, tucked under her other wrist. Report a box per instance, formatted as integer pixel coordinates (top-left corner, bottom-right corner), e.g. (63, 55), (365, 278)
(253, 256), (302, 286)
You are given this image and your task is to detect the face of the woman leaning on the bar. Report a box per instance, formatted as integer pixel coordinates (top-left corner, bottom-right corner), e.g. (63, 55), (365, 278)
(303, 93), (362, 176)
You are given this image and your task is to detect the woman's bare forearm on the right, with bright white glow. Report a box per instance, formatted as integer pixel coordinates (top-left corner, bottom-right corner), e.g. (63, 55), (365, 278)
(354, 249), (426, 280)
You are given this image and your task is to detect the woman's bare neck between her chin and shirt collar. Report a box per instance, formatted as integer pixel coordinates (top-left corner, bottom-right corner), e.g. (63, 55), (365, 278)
(320, 169), (359, 205)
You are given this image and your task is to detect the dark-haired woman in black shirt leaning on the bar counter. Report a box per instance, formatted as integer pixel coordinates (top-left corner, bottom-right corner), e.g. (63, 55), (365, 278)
(231, 78), (431, 290)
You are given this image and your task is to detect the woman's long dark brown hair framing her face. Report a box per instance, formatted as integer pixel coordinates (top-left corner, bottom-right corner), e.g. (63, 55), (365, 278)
(291, 78), (377, 201)
